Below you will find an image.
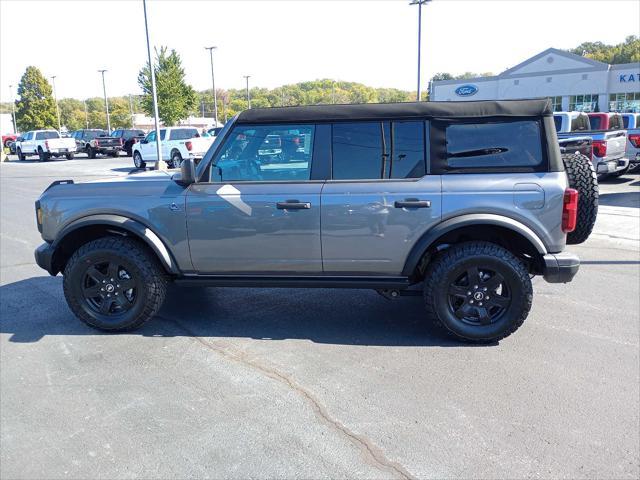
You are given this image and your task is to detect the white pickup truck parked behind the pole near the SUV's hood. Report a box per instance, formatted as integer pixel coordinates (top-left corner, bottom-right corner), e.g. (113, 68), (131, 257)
(132, 127), (214, 168)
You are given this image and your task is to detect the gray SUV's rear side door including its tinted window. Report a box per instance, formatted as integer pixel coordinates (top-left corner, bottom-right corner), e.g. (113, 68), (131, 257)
(322, 121), (441, 275)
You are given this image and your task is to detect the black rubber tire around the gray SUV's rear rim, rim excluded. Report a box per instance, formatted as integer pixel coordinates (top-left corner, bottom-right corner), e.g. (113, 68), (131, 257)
(423, 241), (533, 343)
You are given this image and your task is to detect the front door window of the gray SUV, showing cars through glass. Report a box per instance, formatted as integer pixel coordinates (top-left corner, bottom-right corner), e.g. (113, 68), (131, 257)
(211, 125), (315, 182)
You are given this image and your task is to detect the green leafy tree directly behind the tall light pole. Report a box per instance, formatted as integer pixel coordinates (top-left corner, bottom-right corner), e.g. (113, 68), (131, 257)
(138, 47), (199, 126)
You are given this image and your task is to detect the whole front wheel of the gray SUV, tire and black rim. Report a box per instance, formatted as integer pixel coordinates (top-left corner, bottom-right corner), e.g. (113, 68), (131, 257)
(62, 237), (168, 332)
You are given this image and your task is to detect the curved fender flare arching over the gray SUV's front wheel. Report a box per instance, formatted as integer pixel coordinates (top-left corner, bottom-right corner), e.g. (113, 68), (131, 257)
(51, 214), (180, 275)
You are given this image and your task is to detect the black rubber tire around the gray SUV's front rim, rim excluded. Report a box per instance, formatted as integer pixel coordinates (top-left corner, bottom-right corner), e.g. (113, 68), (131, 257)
(62, 236), (168, 332)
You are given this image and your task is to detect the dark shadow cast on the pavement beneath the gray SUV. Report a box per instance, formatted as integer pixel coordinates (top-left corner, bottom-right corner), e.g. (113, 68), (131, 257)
(0, 276), (482, 347)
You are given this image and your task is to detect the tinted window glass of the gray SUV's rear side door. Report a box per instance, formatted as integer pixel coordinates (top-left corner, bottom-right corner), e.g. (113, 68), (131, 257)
(332, 121), (425, 180)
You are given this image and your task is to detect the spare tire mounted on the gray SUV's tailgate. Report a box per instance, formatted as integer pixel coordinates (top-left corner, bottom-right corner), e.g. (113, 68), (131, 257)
(562, 153), (599, 245)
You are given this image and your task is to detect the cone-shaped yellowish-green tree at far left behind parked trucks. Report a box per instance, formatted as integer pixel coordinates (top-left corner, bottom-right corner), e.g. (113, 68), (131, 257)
(16, 66), (58, 132)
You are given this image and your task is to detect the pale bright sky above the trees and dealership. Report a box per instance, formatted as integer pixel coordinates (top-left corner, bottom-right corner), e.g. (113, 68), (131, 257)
(0, 0), (640, 101)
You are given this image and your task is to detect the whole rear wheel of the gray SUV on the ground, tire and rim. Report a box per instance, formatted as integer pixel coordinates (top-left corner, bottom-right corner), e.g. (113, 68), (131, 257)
(424, 241), (533, 343)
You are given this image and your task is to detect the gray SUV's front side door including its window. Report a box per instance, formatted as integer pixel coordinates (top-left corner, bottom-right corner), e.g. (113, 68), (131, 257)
(187, 125), (323, 275)
